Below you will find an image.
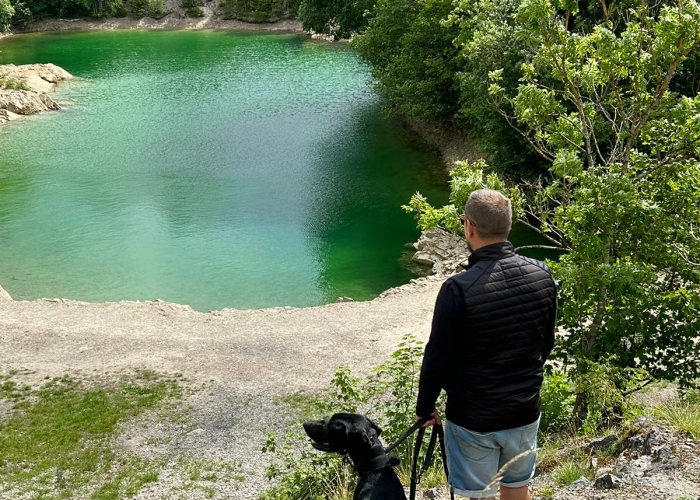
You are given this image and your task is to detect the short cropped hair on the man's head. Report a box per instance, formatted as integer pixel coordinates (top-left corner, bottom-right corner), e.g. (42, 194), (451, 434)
(464, 189), (513, 240)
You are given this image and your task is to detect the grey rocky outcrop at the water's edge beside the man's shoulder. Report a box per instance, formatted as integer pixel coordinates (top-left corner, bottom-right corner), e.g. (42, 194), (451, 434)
(413, 229), (469, 275)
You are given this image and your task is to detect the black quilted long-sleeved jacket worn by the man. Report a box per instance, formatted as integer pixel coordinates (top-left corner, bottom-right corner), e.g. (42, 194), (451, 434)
(416, 242), (557, 432)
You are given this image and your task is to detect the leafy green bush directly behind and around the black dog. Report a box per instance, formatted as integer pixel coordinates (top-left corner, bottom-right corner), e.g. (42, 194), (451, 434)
(262, 335), (441, 500)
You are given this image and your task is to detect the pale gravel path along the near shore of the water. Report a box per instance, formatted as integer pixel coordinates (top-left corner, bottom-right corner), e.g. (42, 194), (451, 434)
(0, 278), (441, 499)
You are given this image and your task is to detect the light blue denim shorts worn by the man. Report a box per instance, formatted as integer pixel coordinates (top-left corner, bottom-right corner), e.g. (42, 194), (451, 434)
(445, 419), (540, 498)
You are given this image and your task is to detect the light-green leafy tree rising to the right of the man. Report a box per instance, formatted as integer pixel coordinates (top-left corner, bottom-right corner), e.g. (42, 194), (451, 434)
(412, 0), (700, 424)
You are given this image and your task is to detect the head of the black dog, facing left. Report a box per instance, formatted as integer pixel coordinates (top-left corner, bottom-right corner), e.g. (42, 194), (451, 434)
(304, 413), (382, 454)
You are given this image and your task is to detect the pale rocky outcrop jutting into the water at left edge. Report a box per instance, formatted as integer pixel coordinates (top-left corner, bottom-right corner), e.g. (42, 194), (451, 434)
(0, 64), (73, 124)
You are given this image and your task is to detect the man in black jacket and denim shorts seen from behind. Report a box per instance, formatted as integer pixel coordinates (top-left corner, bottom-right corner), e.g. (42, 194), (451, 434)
(416, 189), (557, 500)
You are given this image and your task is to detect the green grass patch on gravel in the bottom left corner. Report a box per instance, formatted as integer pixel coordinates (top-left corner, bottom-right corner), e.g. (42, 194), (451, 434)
(0, 372), (182, 499)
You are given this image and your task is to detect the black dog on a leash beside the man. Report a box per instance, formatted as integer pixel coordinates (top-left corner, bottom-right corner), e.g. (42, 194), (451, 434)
(304, 413), (406, 500)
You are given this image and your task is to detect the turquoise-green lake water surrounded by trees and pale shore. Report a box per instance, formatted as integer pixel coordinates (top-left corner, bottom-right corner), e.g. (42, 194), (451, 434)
(0, 31), (447, 310)
